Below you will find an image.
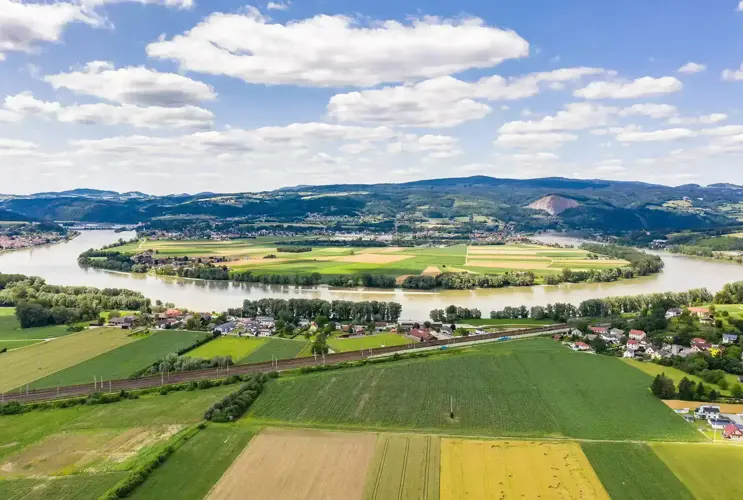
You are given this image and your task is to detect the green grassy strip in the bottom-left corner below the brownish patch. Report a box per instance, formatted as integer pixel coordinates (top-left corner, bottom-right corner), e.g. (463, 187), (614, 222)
(0, 473), (124, 500)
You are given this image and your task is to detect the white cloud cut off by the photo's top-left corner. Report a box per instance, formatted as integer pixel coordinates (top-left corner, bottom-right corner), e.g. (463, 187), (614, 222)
(0, 0), (103, 60)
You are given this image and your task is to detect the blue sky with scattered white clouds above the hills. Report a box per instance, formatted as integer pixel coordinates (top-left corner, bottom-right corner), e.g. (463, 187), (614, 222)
(0, 0), (743, 194)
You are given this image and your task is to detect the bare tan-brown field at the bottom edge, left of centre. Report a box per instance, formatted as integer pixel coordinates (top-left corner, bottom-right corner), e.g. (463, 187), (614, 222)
(206, 429), (376, 500)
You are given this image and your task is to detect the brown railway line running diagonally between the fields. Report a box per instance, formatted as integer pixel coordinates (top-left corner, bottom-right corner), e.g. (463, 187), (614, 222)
(0, 324), (568, 403)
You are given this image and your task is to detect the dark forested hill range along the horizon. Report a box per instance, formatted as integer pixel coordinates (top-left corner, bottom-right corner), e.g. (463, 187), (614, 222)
(0, 176), (743, 231)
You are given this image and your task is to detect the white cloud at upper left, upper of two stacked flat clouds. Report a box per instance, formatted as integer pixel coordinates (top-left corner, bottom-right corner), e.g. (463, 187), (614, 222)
(44, 61), (216, 107)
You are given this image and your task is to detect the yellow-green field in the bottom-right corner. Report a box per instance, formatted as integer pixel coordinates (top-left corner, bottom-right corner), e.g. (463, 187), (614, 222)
(651, 443), (743, 500)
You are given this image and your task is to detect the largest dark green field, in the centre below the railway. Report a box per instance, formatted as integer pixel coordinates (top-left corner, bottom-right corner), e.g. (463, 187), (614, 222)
(249, 339), (704, 441)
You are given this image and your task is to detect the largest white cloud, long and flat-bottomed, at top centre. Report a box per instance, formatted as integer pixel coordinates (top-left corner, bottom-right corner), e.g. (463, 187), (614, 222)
(147, 7), (529, 87)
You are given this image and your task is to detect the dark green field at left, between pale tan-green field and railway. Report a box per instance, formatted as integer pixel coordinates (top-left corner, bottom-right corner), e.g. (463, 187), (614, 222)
(30, 330), (208, 389)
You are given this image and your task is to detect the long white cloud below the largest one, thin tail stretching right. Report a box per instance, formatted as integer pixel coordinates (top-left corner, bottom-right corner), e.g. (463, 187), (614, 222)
(328, 68), (607, 127)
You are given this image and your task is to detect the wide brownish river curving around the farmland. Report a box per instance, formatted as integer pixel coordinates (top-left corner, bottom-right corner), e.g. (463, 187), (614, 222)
(0, 231), (743, 319)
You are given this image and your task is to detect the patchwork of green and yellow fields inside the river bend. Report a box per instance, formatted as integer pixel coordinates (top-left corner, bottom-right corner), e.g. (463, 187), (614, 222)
(119, 238), (628, 277)
